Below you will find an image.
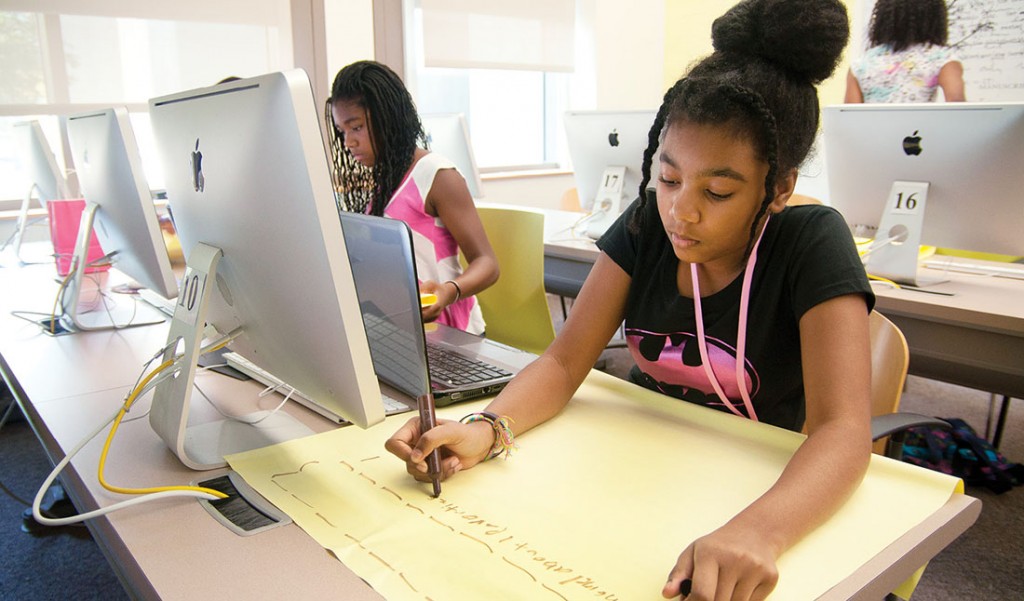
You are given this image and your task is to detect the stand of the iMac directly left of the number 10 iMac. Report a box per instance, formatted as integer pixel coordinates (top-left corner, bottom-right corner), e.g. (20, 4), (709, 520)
(47, 202), (165, 332)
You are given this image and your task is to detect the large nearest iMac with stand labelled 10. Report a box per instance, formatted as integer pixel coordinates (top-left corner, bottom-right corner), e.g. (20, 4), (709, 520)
(150, 70), (384, 470)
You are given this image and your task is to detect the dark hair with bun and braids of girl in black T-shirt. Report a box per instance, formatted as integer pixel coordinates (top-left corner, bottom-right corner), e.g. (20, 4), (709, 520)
(630, 0), (850, 250)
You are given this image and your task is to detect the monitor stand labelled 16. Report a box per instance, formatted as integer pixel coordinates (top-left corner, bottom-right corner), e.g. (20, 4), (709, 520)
(865, 181), (945, 287)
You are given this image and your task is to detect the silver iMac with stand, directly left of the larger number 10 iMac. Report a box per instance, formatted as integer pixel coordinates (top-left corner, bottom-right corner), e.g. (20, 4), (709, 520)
(60, 109), (178, 331)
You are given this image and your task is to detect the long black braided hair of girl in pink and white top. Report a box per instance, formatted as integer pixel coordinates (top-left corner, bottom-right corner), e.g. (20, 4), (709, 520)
(327, 60), (427, 215)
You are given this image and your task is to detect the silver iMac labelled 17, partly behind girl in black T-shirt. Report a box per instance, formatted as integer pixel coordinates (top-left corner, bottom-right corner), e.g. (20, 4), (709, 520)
(565, 111), (657, 239)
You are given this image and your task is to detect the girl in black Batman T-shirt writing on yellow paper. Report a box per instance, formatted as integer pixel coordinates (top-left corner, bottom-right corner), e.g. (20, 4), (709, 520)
(386, 0), (874, 601)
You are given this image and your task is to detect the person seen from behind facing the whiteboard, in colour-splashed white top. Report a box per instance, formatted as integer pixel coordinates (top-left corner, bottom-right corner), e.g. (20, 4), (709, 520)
(846, 0), (966, 102)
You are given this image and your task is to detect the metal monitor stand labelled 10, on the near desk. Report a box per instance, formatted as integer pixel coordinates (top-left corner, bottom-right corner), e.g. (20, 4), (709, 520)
(150, 244), (312, 470)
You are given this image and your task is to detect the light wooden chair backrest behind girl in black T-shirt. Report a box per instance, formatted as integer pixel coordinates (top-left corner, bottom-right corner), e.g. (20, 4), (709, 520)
(869, 311), (910, 455)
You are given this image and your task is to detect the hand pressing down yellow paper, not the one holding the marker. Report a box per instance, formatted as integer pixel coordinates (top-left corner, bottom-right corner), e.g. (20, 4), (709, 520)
(662, 524), (778, 601)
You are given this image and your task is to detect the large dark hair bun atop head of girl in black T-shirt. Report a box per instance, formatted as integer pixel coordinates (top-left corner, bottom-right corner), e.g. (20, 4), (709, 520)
(712, 0), (850, 84)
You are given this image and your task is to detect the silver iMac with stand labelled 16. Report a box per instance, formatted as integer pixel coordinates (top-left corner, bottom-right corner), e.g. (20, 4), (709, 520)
(822, 102), (1024, 286)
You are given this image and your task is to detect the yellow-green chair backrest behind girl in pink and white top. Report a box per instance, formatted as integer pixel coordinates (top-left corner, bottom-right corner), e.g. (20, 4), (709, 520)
(468, 207), (555, 354)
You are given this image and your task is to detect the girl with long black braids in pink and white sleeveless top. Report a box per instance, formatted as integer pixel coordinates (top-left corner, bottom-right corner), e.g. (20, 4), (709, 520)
(328, 60), (498, 334)
